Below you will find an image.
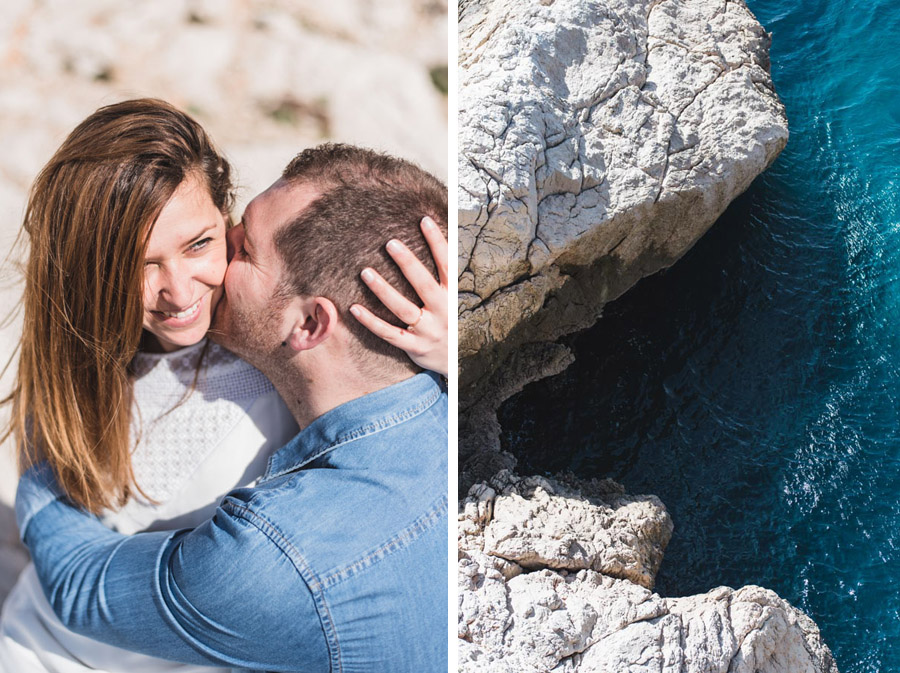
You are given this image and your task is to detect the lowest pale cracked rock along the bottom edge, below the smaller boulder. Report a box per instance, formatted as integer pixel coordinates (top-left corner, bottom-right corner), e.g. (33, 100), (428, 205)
(457, 516), (837, 673)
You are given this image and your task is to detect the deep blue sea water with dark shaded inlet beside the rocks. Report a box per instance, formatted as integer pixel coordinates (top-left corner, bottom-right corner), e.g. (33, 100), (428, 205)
(501, 0), (900, 673)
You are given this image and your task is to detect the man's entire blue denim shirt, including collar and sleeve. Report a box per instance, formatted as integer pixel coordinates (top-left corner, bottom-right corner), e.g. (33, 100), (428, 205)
(16, 373), (448, 673)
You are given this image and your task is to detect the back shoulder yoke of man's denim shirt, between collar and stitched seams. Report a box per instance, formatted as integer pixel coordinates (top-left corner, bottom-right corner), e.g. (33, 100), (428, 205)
(223, 400), (448, 575)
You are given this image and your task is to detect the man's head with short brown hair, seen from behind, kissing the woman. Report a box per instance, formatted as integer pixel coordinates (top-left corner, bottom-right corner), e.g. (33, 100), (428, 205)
(215, 144), (447, 380)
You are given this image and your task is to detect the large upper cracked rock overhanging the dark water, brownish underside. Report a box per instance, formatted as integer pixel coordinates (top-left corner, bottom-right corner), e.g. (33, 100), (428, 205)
(458, 0), (788, 396)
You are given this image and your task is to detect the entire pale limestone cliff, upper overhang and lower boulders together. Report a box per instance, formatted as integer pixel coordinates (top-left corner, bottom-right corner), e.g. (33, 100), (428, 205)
(458, 0), (837, 673)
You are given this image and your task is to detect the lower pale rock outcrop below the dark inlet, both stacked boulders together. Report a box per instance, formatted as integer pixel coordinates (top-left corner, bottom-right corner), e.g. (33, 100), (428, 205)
(457, 471), (837, 673)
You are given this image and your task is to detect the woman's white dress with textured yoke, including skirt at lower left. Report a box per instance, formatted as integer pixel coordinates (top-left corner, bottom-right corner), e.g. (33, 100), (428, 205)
(0, 341), (298, 673)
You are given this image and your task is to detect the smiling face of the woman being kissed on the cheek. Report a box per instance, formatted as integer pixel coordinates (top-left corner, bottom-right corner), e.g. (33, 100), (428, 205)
(144, 177), (228, 352)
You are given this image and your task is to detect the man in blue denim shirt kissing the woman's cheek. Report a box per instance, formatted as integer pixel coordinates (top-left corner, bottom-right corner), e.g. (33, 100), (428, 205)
(16, 145), (448, 671)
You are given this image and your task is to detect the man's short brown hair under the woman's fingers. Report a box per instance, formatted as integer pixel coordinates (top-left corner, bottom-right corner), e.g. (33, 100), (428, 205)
(275, 143), (447, 371)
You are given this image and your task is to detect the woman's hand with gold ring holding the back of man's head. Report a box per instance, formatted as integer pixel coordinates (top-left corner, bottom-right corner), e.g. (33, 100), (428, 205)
(350, 217), (450, 376)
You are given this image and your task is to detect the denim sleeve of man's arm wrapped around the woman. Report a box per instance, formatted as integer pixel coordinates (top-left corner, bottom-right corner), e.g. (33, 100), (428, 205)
(16, 469), (330, 671)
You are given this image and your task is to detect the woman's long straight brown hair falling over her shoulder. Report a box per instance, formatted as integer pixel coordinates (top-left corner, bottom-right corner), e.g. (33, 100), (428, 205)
(4, 99), (233, 513)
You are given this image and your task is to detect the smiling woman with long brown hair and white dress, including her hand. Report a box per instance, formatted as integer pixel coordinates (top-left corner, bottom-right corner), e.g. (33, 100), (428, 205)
(0, 100), (446, 673)
